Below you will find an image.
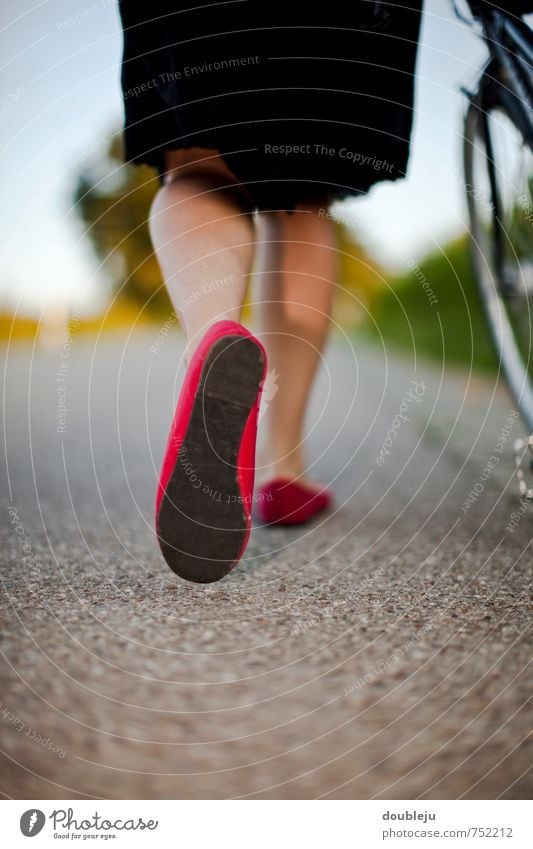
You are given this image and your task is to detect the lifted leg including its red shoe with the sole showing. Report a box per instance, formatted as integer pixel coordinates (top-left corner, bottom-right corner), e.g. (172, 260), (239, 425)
(150, 150), (265, 582)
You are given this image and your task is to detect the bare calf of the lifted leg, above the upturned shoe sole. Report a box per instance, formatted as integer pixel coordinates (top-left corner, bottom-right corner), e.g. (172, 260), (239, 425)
(150, 148), (254, 356)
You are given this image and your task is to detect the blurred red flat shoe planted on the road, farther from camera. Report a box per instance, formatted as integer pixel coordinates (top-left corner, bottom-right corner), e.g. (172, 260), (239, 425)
(257, 478), (333, 525)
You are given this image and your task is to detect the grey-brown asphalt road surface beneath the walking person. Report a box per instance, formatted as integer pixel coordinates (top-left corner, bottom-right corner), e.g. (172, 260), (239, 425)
(0, 331), (533, 799)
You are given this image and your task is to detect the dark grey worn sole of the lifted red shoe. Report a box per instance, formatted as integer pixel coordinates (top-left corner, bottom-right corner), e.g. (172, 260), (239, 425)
(157, 335), (265, 583)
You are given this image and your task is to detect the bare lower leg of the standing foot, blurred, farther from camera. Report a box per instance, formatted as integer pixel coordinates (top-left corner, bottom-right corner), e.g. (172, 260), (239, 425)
(256, 201), (337, 485)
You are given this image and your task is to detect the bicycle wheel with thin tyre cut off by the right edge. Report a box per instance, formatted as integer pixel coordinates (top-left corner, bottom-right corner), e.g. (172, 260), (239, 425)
(464, 76), (533, 433)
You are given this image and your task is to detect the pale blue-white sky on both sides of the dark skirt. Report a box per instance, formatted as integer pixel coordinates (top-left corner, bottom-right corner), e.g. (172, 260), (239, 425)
(0, 0), (492, 311)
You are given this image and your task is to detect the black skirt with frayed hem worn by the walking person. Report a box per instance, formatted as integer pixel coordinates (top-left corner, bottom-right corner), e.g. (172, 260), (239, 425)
(120, 0), (422, 209)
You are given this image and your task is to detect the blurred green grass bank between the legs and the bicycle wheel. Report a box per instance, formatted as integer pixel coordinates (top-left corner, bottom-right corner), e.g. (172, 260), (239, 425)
(364, 237), (497, 372)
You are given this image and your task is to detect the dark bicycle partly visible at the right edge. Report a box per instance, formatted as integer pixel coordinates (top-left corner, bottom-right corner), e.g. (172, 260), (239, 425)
(453, 0), (533, 501)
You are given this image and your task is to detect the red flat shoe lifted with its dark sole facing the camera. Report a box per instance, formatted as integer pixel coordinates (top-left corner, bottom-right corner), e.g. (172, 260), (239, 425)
(156, 321), (266, 583)
